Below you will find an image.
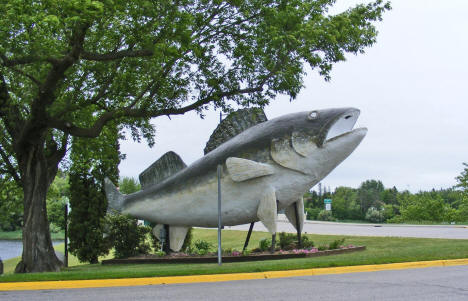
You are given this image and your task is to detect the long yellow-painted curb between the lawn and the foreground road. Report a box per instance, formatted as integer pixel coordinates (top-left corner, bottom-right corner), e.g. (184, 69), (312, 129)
(0, 258), (468, 291)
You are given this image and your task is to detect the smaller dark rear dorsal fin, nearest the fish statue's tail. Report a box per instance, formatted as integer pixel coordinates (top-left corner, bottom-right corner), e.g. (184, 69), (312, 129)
(139, 152), (187, 189)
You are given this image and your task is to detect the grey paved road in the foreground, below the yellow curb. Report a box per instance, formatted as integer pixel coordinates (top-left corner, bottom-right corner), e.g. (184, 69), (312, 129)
(0, 266), (468, 301)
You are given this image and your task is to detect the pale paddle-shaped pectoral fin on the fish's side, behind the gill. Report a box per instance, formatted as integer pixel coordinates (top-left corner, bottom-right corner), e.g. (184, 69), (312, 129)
(226, 157), (274, 182)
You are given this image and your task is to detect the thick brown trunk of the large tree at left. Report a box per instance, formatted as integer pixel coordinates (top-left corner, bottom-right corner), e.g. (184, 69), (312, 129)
(15, 143), (63, 273)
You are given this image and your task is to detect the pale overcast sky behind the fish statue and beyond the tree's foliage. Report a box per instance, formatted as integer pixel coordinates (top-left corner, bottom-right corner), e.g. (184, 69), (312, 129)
(119, 0), (468, 192)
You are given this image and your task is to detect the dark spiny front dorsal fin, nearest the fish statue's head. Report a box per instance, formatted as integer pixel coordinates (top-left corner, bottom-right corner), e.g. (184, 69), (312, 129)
(204, 108), (267, 155)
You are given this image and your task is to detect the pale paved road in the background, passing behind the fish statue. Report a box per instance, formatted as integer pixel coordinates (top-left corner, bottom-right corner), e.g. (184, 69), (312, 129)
(226, 221), (468, 239)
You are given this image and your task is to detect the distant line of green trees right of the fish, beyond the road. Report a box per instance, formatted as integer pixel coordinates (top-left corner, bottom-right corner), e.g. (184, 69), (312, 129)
(304, 163), (468, 223)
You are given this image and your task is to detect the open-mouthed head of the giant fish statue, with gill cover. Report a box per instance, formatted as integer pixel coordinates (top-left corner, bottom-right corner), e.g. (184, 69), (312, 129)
(271, 108), (367, 181)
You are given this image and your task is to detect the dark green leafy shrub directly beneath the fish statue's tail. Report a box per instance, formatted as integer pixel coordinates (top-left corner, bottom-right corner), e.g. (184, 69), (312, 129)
(106, 214), (151, 258)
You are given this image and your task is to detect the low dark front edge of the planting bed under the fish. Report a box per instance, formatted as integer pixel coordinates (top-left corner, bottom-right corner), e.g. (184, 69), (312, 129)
(102, 246), (366, 264)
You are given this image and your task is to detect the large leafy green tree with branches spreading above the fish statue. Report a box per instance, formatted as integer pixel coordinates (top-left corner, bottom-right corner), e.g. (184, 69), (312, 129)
(0, 0), (390, 272)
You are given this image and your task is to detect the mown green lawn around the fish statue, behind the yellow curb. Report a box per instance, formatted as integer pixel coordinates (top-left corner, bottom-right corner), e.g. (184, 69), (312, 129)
(0, 229), (468, 282)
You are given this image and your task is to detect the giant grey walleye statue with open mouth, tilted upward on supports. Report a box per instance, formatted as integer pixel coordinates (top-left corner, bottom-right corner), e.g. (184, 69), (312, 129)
(105, 108), (367, 251)
